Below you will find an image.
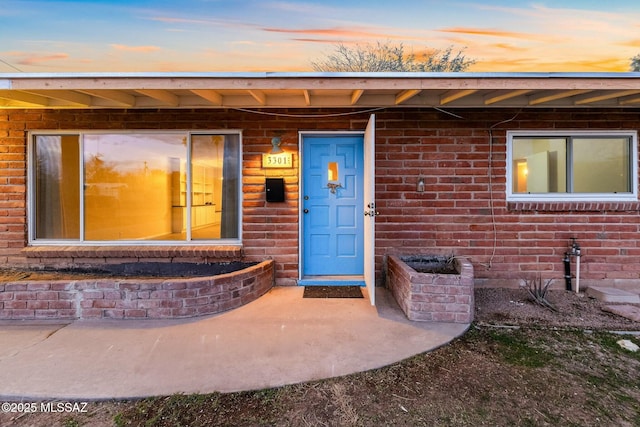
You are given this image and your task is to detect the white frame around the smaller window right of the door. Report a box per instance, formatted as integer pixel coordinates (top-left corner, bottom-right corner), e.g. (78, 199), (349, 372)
(506, 129), (638, 202)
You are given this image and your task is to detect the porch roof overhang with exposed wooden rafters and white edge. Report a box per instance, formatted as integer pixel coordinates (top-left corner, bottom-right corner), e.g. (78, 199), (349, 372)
(0, 72), (640, 109)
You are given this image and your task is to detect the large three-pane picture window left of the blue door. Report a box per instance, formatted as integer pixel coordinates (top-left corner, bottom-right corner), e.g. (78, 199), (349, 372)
(30, 132), (241, 243)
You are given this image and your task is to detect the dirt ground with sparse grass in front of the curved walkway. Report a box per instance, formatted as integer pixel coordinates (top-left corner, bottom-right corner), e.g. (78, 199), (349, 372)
(0, 282), (640, 427)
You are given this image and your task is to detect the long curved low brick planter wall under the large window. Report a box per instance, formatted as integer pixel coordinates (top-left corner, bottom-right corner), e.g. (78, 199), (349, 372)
(0, 260), (274, 320)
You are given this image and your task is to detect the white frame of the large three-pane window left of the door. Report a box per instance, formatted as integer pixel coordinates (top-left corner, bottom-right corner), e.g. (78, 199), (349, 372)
(27, 129), (243, 246)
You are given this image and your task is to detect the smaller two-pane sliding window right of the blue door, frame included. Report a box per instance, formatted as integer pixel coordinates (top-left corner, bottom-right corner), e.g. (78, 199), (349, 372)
(507, 131), (638, 201)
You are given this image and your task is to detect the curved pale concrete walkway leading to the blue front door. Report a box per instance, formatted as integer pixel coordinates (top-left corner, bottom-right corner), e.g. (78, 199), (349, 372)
(0, 287), (468, 401)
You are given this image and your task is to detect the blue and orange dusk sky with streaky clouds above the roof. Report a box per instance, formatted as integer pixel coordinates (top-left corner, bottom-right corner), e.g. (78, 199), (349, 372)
(0, 0), (640, 73)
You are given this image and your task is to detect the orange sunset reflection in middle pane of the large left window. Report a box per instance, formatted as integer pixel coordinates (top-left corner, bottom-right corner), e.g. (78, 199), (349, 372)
(84, 134), (186, 240)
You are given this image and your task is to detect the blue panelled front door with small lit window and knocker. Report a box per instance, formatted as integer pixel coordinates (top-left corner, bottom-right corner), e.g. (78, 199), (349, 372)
(302, 135), (364, 278)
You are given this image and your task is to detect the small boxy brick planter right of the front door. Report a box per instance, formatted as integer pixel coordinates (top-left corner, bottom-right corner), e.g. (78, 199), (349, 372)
(386, 255), (474, 323)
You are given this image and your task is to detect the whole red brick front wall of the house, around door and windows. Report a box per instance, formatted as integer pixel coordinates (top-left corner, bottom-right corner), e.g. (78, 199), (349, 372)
(0, 109), (640, 286)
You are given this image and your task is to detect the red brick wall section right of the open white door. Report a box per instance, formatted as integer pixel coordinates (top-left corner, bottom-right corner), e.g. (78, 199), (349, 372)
(376, 110), (640, 286)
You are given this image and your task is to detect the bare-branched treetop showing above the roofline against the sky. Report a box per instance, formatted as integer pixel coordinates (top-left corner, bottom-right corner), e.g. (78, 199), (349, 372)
(311, 42), (476, 72)
